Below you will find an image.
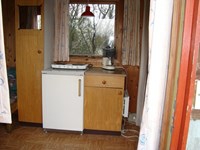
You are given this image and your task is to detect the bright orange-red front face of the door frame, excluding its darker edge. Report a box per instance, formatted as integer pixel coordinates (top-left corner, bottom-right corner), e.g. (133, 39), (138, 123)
(170, 0), (194, 149)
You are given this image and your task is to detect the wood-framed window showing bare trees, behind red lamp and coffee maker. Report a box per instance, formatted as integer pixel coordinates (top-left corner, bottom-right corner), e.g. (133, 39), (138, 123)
(69, 0), (124, 66)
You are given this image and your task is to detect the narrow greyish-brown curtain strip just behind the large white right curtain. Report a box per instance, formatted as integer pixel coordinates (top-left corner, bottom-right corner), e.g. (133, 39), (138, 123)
(136, 0), (150, 126)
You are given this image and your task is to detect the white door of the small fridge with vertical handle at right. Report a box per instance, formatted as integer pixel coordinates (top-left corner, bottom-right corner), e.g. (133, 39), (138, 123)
(42, 74), (84, 131)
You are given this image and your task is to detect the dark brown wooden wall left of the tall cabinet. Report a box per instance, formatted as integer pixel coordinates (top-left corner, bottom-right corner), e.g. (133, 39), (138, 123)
(2, 0), (16, 67)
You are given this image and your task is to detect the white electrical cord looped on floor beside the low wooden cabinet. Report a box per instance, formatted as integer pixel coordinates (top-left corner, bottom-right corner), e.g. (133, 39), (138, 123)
(121, 117), (139, 141)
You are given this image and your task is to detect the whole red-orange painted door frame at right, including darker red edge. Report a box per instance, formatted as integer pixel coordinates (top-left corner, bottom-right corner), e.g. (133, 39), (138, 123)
(170, 0), (200, 149)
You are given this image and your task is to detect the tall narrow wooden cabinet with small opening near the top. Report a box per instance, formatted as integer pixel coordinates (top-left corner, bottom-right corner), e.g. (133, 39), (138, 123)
(15, 0), (44, 123)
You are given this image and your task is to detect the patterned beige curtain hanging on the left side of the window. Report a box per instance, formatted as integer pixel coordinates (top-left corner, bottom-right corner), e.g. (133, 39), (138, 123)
(54, 0), (69, 61)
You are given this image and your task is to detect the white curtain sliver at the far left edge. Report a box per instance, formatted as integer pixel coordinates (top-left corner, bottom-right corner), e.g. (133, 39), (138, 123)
(0, 3), (11, 123)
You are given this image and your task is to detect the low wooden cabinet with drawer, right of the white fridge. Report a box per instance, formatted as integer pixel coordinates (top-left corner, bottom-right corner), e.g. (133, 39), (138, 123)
(84, 68), (125, 131)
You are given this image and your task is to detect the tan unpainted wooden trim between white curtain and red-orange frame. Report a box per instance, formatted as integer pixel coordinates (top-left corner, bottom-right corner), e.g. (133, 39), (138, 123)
(160, 0), (185, 149)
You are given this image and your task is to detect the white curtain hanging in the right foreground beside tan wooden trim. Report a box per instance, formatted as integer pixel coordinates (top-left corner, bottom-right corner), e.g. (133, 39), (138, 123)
(138, 0), (173, 150)
